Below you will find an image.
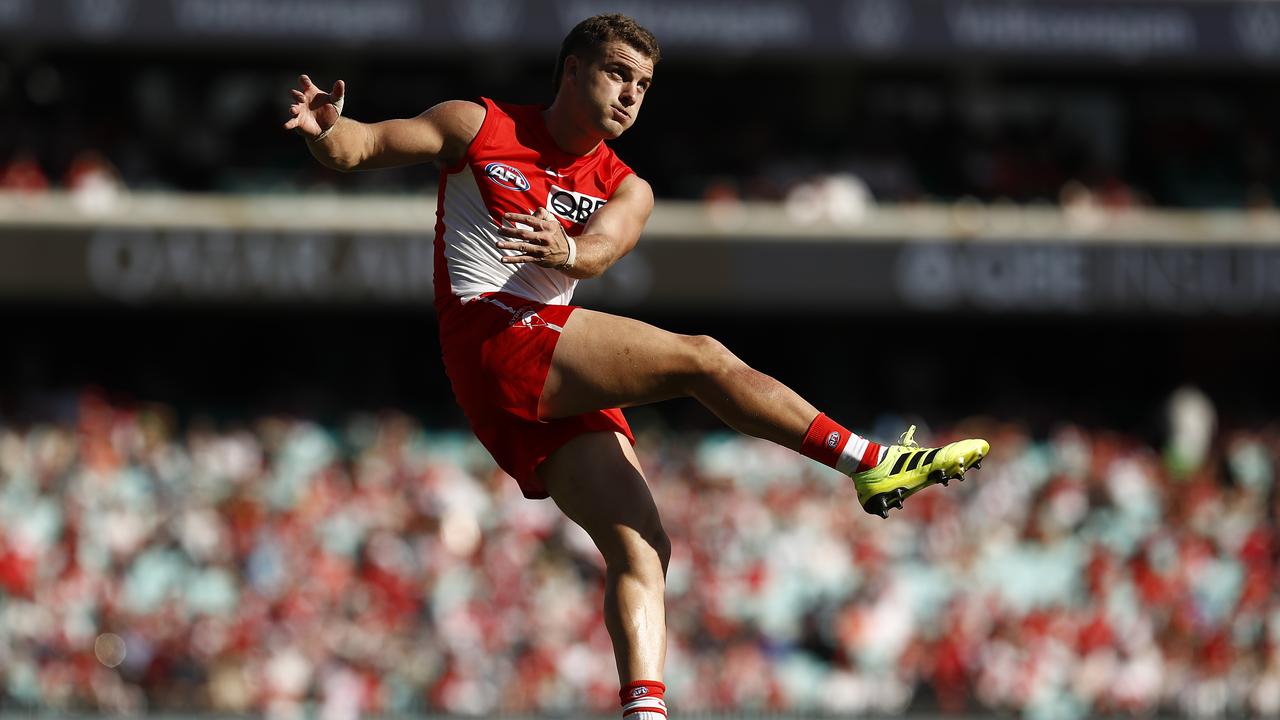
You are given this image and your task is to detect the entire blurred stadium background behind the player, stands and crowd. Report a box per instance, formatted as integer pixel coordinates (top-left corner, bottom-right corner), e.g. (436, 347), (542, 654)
(0, 0), (1280, 720)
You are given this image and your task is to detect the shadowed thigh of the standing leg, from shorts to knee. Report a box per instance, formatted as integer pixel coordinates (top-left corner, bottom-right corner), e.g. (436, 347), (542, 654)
(538, 433), (671, 570)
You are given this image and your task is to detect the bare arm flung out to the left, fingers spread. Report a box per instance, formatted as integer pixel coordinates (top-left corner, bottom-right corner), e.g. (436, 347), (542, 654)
(284, 76), (485, 172)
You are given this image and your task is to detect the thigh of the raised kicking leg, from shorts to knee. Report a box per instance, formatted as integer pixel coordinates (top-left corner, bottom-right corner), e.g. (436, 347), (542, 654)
(539, 309), (722, 418)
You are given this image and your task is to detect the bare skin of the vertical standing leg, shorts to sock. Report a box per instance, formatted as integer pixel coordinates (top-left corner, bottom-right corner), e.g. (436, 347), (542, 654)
(538, 433), (671, 685)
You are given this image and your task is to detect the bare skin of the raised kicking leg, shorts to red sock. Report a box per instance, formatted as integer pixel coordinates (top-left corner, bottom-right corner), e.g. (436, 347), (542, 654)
(539, 310), (818, 450)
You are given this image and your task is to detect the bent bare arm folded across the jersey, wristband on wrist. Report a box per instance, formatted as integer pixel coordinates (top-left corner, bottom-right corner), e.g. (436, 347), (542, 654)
(488, 174), (653, 279)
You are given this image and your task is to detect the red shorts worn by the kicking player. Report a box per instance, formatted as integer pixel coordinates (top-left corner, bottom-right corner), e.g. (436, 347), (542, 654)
(436, 292), (635, 498)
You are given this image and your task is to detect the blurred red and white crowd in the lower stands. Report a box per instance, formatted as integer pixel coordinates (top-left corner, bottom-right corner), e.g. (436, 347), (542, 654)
(0, 392), (1280, 720)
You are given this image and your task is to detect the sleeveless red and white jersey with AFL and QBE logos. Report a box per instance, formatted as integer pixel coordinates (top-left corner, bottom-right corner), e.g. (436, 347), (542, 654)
(435, 97), (631, 305)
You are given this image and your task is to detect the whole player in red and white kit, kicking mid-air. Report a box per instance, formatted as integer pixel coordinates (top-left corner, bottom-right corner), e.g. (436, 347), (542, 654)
(284, 15), (988, 720)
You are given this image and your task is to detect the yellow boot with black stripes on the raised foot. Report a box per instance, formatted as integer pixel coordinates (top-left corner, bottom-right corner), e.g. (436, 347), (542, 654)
(852, 425), (991, 518)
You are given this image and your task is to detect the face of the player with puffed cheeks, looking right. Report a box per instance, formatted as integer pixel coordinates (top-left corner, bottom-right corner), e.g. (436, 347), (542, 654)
(577, 42), (653, 140)
